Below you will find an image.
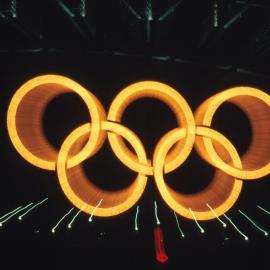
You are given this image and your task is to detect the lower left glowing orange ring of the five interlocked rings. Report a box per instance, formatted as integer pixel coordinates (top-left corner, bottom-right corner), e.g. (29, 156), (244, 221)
(57, 121), (147, 217)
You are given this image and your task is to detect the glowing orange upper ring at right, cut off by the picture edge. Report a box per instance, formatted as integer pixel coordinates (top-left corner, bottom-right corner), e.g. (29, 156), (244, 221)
(195, 87), (270, 180)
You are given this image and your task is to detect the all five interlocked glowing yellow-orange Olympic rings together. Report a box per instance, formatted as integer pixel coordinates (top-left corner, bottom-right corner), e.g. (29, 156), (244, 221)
(7, 75), (270, 220)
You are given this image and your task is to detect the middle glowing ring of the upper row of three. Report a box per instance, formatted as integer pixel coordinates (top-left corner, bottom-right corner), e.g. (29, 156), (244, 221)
(108, 81), (195, 175)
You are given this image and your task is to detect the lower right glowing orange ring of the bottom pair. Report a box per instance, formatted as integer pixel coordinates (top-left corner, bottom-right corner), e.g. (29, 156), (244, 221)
(154, 127), (242, 220)
